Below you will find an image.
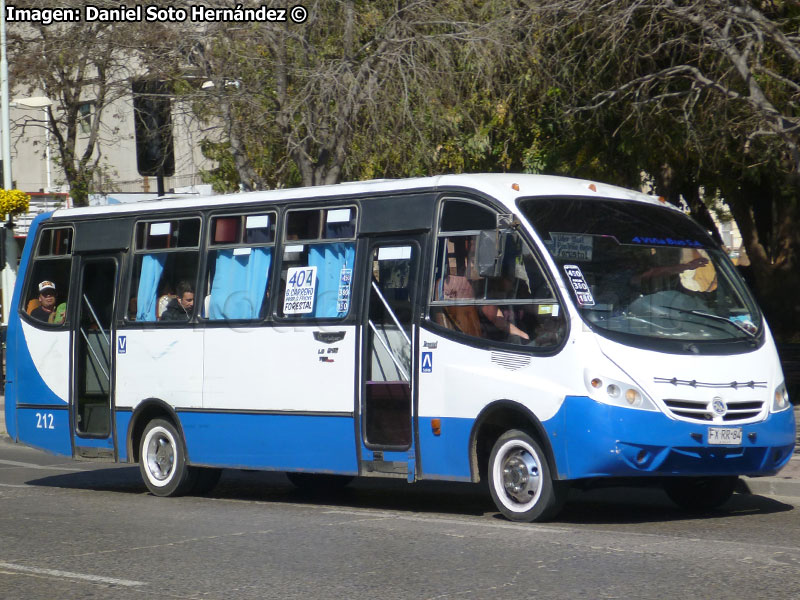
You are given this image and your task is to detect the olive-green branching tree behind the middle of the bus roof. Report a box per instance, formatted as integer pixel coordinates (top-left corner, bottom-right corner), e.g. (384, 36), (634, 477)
(167, 0), (520, 189)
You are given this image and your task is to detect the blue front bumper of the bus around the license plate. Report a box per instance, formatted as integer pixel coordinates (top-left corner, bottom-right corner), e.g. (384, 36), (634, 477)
(543, 396), (795, 479)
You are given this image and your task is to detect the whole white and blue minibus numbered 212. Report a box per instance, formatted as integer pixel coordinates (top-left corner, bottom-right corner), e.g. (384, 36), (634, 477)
(5, 175), (795, 521)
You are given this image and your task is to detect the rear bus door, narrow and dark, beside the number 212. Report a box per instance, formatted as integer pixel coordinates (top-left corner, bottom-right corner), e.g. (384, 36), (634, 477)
(70, 254), (120, 460)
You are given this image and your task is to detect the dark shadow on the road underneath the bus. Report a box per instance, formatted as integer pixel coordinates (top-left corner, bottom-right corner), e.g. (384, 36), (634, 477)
(27, 466), (794, 525)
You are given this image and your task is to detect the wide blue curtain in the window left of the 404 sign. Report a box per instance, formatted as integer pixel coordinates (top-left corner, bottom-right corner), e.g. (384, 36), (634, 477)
(208, 248), (272, 319)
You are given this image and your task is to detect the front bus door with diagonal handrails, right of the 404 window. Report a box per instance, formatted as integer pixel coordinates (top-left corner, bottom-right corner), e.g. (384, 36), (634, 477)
(359, 236), (423, 480)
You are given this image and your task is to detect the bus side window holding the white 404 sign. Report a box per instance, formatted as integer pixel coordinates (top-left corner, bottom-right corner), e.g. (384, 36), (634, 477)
(278, 207), (356, 319)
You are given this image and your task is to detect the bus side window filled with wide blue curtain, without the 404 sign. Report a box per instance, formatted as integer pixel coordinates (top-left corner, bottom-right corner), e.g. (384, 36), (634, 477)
(201, 213), (276, 320)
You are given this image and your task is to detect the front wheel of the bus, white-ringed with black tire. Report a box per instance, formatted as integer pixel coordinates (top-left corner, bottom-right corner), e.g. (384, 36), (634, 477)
(487, 429), (568, 523)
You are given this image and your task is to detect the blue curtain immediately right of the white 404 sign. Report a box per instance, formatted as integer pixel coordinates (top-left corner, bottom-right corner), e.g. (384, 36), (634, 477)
(308, 242), (356, 317)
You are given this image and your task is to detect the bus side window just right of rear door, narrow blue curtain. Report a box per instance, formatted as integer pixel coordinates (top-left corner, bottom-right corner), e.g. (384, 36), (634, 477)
(126, 217), (200, 322)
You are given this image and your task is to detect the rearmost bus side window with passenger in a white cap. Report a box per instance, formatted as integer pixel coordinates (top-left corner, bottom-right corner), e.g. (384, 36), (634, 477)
(20, 227), (72, 326)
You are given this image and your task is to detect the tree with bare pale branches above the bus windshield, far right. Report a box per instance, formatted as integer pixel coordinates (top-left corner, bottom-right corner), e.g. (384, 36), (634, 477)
(530, 0), (800, 338)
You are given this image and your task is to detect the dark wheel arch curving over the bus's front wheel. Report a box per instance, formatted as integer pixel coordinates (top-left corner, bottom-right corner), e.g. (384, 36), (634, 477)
(469, 400), (558, 483)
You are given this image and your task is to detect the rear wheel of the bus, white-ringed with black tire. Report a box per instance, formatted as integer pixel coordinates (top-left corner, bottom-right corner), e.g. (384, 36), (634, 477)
(139, 419), (196, 496)
